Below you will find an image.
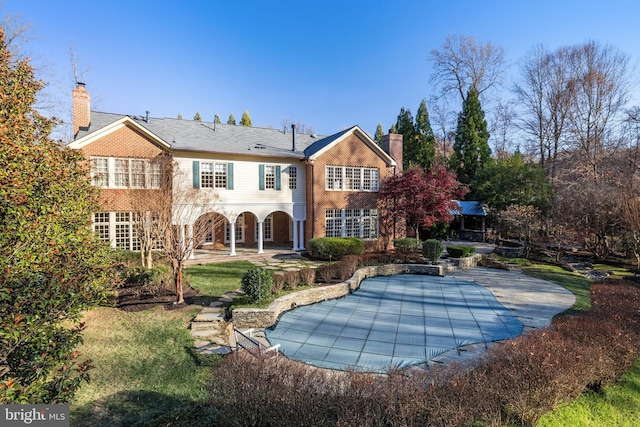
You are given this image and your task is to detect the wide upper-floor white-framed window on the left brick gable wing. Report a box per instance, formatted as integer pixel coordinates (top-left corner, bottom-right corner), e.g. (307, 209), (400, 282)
(90, 157), (162, 189)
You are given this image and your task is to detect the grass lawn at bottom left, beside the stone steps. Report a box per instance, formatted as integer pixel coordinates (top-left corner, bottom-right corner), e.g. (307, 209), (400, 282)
(70, 307), (216, 427)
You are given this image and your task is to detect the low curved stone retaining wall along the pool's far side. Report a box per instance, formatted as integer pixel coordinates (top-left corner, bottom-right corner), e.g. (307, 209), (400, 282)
(232, 264), (443, 329)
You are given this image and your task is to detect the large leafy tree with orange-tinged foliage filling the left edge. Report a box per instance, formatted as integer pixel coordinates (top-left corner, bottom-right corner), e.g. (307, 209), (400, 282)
(0, 27), (117, 404)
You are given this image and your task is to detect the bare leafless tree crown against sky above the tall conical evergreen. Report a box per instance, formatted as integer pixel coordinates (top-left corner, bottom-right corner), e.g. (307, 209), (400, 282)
(431, 35), (506, 101)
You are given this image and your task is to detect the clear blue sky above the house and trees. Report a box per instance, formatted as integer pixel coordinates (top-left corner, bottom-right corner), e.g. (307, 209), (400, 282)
(0, 0), (640, 140)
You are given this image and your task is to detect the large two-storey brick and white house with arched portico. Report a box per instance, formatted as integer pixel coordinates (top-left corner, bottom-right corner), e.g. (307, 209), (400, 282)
(70, 84), (402, 255)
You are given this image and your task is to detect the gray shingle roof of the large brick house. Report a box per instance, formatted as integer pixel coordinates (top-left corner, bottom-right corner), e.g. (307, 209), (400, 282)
(76, 111), (330, 159)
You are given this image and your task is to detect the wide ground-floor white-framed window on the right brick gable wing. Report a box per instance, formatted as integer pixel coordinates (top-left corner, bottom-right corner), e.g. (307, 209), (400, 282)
(324, 209), (379, 239)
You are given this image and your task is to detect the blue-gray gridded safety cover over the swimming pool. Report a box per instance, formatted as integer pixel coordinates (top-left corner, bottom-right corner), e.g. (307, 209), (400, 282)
(265, 274), (523, 372)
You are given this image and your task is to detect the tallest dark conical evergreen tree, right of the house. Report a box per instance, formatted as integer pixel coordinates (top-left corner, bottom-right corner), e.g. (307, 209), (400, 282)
(450, 86), (491, 187)
